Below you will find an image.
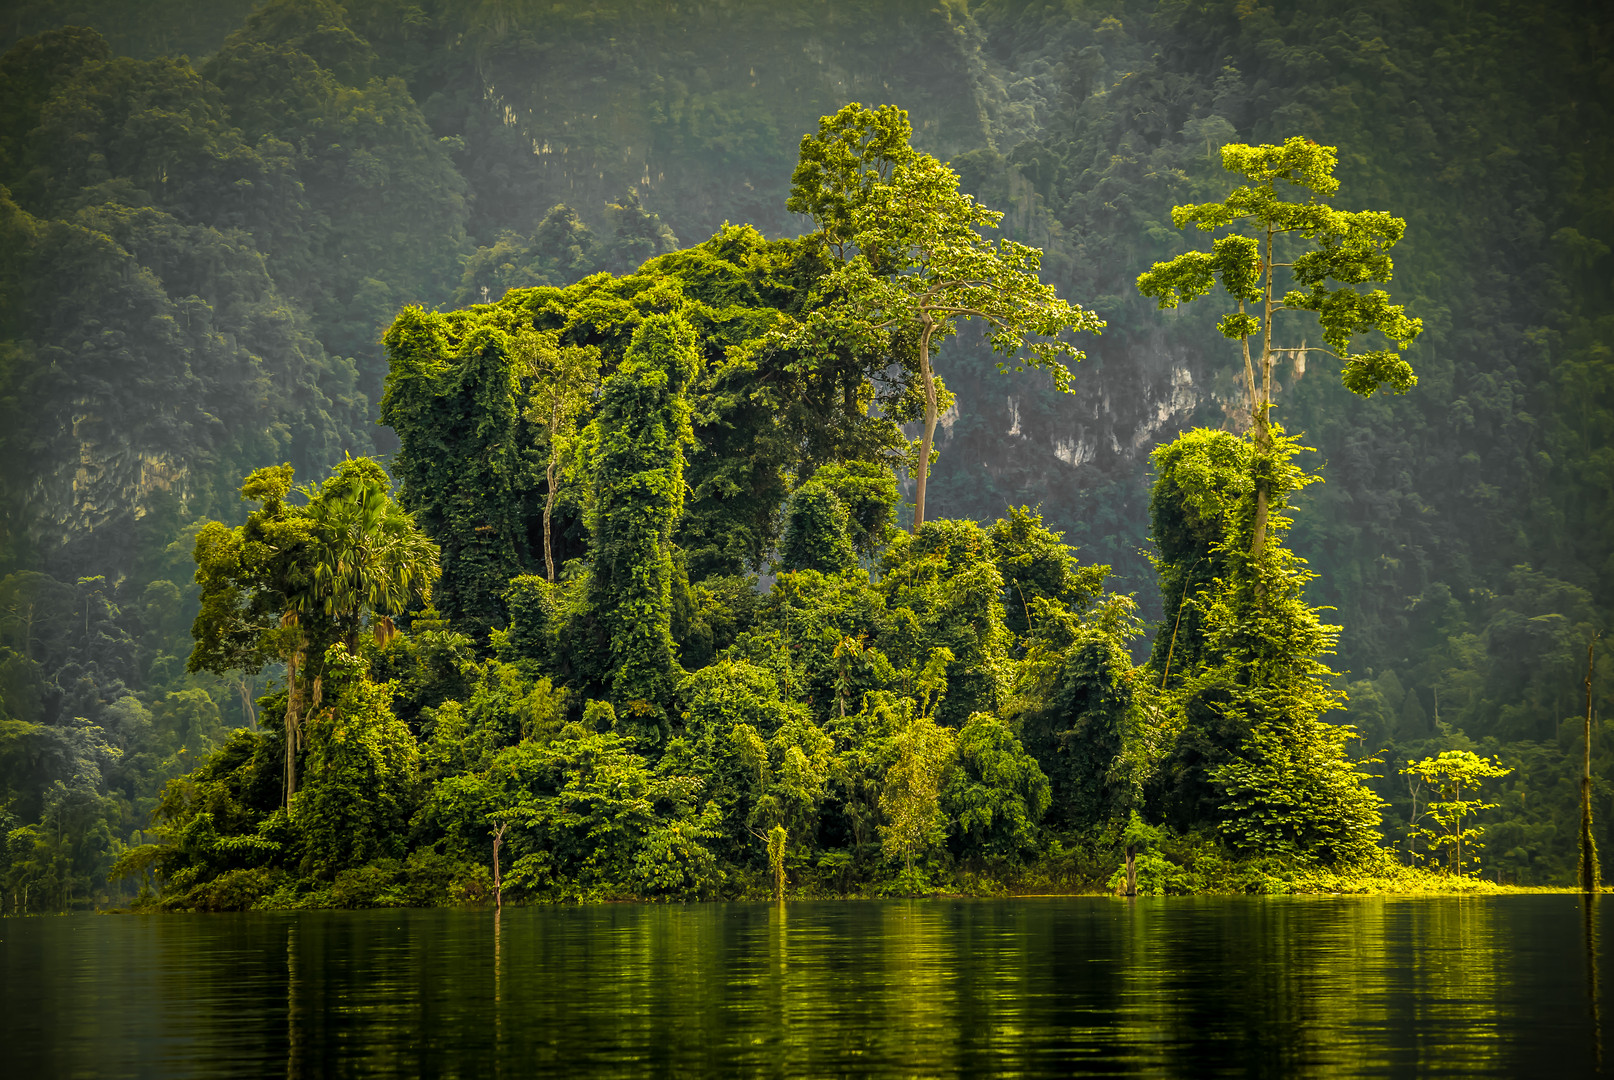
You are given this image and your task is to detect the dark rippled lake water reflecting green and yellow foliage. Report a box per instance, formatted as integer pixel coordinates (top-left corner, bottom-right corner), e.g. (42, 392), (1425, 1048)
(0, 896), (1614, 1078)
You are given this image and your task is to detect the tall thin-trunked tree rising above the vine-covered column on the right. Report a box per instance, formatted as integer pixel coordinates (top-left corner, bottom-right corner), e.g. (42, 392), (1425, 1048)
(1138, 136), (1424, 552)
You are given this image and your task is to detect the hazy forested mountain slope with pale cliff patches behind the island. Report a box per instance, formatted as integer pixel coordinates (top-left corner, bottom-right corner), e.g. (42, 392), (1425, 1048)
(0, 0), (1614, 896)
